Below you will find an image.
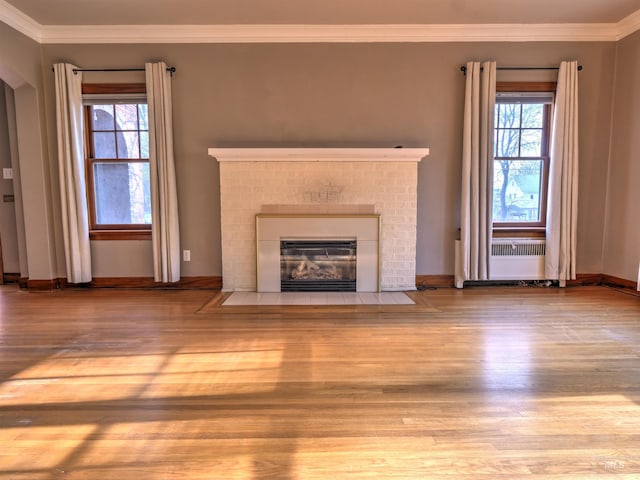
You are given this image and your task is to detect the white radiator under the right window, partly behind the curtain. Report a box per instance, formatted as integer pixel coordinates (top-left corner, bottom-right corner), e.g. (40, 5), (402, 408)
(455, 238), (546, 288)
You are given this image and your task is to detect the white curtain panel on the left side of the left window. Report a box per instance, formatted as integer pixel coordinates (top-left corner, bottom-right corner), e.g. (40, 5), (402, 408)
(53, 63), (91, 283)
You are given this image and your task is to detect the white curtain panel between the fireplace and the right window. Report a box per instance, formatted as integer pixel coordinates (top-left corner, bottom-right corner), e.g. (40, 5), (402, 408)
(459, 62), (496, 280)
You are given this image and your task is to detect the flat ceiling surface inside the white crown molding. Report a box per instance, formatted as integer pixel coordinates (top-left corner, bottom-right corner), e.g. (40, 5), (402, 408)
(6, 0), (640, 25)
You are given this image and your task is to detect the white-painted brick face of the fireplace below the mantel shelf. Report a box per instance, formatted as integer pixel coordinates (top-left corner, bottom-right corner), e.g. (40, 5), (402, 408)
(220, 161), (417, 291)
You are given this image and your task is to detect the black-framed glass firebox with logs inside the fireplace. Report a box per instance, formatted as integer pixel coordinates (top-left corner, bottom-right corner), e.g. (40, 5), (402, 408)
(280, 239), (357, 292)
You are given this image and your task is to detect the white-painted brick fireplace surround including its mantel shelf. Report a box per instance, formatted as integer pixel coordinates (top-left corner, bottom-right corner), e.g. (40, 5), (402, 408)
(209, 148), (429, 291)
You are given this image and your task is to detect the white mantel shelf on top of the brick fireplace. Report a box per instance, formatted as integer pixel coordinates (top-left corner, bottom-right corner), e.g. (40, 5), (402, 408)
(209, 148), (429, 162)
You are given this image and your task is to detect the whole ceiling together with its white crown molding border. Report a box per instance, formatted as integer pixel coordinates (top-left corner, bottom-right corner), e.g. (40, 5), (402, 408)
(0, 0), (640, 43)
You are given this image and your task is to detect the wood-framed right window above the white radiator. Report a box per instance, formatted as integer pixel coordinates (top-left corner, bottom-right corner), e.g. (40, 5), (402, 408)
(493, 83), (555, 230)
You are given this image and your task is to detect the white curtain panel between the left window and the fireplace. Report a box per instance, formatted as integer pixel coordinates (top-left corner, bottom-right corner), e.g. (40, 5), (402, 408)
(145, 62), (180, 283)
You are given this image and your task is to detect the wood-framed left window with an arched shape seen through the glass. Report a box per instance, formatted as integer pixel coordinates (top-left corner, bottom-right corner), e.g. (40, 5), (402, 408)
(83, 84), (151, 239)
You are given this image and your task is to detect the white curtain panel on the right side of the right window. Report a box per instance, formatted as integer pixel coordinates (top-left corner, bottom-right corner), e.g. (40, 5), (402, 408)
(545, 61), (578, 286)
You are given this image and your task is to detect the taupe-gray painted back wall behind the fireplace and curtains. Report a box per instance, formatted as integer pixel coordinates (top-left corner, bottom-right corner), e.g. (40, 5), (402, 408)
(43, 43), (615, 276)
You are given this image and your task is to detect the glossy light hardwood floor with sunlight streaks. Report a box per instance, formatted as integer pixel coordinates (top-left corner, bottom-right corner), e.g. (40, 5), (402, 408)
(0, 286), (640, 480)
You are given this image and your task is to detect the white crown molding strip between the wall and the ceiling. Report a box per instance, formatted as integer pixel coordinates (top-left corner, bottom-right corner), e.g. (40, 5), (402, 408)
(0, 0), (640, 44)
